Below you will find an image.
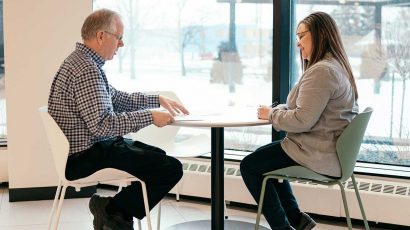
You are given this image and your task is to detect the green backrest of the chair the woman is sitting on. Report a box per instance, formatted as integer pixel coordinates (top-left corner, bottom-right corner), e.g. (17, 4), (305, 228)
(336, 107), (373, 181)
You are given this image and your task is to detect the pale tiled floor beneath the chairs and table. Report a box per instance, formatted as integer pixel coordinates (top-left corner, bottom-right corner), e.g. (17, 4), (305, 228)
(0, 186), (378, 230)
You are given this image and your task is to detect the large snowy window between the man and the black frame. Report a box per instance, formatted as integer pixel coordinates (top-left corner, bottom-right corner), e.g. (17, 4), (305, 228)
(94, 0), (273, 154)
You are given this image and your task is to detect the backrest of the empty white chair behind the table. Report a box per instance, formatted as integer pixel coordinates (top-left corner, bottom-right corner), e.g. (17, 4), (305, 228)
(130, 91), (182, 148)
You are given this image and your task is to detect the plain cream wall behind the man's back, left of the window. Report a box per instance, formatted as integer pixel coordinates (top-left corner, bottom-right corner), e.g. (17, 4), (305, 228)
(2, 0), (92, 190)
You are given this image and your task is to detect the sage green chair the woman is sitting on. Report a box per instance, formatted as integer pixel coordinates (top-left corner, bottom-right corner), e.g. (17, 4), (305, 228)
(255, 107), (373, 230)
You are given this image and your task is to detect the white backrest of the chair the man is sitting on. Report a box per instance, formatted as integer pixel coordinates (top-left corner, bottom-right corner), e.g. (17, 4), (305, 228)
(38, 106), (70, 181)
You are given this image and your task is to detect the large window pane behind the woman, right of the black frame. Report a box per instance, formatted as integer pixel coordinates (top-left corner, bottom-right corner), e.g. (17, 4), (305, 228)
(294, 0), (410, 166)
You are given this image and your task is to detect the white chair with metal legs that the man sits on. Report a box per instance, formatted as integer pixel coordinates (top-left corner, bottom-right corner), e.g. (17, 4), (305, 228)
(39, 106), (160, 230)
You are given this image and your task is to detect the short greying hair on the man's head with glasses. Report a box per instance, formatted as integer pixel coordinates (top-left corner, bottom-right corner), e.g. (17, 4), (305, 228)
(81, 9), (120, 40)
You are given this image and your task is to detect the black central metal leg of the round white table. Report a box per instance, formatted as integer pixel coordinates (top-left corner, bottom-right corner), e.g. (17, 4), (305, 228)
(211, 127), (225, 230)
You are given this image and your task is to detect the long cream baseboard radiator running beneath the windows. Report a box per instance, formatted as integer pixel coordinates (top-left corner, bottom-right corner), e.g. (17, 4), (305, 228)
(171, 158), (410, 226)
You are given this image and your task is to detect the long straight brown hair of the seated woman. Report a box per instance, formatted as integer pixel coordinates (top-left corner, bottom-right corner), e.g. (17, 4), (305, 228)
(298, 12), (358, 100)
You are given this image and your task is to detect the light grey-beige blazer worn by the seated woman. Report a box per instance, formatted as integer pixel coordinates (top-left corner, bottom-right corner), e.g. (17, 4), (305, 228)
(269, 53), (358, 177)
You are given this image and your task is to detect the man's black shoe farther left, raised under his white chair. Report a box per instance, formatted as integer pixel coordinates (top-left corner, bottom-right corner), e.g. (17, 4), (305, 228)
(88, 194), (111, 230)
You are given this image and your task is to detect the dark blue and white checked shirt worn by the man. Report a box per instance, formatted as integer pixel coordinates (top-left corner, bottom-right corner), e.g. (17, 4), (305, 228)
(48, 43), (159, 155)
